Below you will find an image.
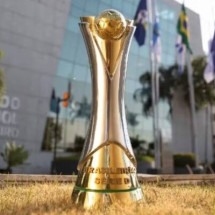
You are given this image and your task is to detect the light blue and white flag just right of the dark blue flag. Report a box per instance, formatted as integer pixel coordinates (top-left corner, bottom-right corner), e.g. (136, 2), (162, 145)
(152, 17), (161, 63)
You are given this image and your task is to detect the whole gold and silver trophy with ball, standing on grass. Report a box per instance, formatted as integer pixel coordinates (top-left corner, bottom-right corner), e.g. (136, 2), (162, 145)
(72, 9), (143, 209)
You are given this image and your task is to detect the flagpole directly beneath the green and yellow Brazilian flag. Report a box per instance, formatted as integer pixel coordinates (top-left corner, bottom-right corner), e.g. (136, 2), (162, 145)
(186, 53), (199, 167)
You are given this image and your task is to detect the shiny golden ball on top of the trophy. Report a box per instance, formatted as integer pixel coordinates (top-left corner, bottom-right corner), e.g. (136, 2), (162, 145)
(95, 9), (127, 40)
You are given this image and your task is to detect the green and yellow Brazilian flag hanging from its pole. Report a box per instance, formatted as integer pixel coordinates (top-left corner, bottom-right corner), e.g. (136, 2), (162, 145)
(177, 4), (192, 54)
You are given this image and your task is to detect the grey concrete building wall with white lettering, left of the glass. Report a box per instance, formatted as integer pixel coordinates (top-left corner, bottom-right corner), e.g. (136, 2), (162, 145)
(0, 0), (70, 173)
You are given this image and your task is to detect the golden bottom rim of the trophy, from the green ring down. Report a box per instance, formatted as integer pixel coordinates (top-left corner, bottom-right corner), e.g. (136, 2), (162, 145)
(72, 187), (143, 210)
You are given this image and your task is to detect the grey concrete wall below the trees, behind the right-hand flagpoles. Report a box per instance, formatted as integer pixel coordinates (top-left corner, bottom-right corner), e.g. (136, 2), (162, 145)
(172, 91), (213, 162)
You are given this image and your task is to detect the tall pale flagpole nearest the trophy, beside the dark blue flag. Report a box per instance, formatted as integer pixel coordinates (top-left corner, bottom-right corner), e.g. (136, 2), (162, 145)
(147, 0), (161, 169)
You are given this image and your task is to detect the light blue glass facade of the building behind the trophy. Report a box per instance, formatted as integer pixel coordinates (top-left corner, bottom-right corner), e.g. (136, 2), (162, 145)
(42, 0), (178, 151)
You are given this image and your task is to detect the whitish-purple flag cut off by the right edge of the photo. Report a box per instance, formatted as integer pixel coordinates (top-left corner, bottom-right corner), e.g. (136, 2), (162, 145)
(204, 32), (215, 83)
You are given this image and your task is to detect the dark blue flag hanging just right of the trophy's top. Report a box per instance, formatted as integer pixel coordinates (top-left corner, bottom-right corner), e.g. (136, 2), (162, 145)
(134, 0), (147, 46)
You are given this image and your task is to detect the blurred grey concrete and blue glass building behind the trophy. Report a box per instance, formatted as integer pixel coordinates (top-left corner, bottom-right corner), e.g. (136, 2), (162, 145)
(0, 0), (213, 173)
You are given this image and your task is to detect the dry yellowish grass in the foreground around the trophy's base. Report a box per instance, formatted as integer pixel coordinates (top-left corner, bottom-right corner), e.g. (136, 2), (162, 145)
(0, 182), (215, 215)
